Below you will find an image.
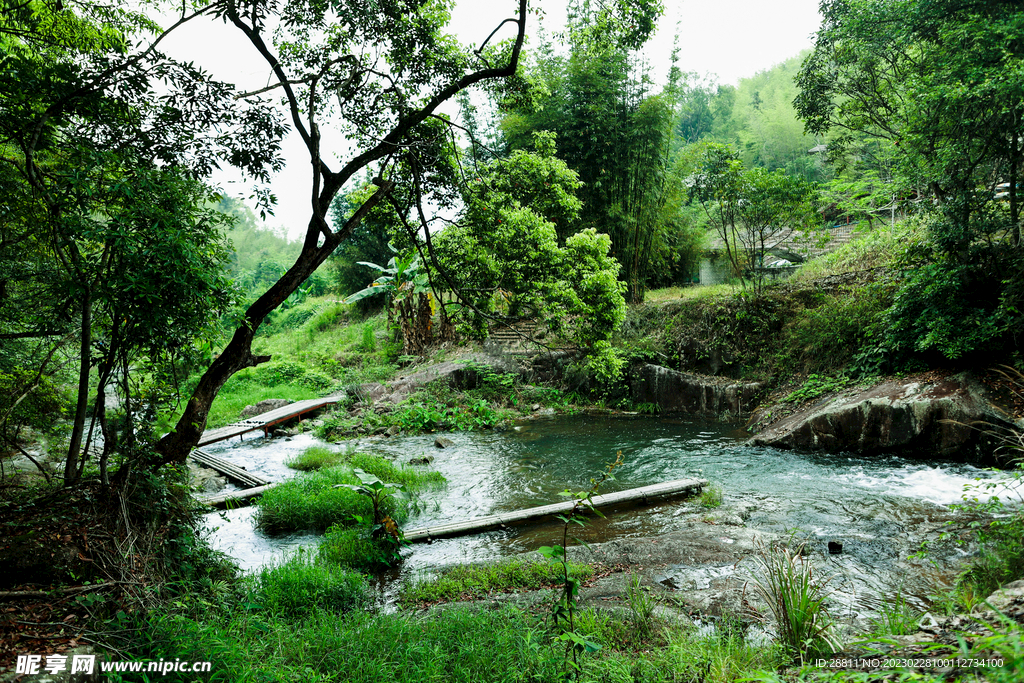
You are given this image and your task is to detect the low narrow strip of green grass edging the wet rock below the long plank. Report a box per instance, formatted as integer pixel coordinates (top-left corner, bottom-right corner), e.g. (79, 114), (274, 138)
(398, 559), (594, 605)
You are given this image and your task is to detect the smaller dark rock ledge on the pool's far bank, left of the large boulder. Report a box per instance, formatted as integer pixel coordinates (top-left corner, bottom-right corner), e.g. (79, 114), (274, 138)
(633, 364), (761, 419)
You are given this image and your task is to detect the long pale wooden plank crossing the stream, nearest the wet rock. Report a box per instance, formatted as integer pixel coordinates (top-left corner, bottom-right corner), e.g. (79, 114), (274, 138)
(406, 479), (708, 543)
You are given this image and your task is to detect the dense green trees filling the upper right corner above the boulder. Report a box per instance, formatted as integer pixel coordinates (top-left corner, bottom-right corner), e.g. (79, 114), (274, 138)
(796, 0), (1024, 360)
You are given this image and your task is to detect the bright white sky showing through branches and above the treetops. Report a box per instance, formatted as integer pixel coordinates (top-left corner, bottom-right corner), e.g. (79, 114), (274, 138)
(155, 0), (820, 239)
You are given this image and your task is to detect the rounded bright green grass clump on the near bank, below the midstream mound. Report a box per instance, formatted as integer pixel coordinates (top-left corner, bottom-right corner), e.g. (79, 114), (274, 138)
(255, 552), (372, 617)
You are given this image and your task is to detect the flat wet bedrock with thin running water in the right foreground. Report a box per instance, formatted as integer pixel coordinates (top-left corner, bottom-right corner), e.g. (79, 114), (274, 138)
(417, 497), (983, 638)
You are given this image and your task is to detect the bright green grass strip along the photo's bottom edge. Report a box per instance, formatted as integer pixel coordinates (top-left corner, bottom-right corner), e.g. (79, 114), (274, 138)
(119, 605), (794, 683)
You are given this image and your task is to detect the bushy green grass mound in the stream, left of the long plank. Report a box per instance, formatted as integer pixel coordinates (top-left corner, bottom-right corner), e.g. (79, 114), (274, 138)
(255, 454), (444, 533)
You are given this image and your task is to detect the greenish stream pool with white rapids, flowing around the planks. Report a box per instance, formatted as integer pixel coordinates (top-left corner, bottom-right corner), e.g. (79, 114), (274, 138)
(206, 416), (996, 570)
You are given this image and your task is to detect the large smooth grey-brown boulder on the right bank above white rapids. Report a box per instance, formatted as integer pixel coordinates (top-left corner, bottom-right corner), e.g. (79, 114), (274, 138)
(752, 373), (1021, 460)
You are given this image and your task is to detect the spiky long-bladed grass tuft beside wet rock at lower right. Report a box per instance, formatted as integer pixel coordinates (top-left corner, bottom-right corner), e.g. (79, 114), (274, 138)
(754, 545), (839, 664)
